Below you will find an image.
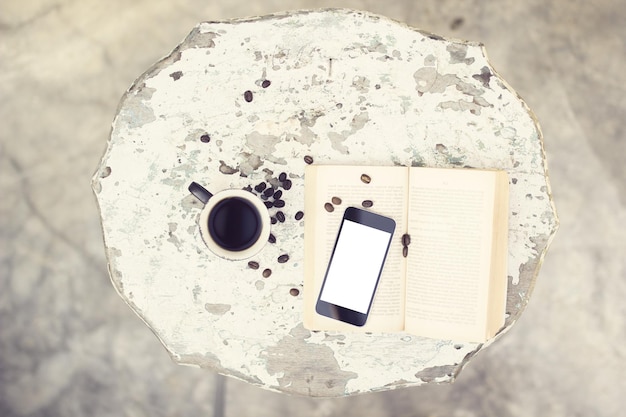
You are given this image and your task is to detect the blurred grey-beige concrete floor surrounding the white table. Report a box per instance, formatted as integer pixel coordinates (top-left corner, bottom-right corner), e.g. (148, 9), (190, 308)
(0, 0), (626, 417)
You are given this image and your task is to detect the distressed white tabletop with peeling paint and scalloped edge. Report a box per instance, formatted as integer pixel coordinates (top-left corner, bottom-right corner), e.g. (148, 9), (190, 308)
(93, 10), (558, 396)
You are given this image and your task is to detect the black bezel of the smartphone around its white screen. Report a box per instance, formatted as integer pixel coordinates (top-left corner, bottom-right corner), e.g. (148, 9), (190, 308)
(315, 207), (396, 327)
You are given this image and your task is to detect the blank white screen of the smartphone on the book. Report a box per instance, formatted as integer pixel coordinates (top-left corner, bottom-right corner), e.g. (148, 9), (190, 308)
(320, 220), (391, 314)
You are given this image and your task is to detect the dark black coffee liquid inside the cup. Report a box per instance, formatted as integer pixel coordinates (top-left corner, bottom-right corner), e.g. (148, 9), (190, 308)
(208, 197), (261, 251)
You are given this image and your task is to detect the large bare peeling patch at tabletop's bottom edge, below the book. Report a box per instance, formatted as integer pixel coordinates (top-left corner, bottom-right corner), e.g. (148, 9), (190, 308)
(262, 324), (358, 397)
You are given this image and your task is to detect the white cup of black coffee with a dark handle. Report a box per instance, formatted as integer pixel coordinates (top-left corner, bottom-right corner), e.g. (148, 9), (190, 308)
(189, 182), (270, 259)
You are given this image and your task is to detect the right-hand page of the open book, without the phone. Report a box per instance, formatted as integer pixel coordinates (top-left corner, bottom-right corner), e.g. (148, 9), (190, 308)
(406, 168), (495, 341)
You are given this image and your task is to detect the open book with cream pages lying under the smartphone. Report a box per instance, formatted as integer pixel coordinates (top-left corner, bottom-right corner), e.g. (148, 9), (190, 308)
(304, 165), (509, 342)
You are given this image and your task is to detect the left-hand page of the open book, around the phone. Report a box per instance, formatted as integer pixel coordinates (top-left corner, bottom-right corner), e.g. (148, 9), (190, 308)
(304, 165), (408, 331)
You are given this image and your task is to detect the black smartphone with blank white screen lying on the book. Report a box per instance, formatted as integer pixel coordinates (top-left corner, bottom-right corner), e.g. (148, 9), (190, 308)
(315, 207), (396, 326)
